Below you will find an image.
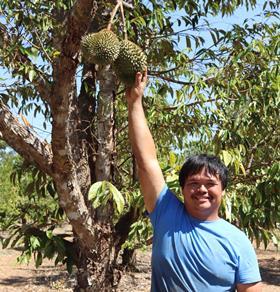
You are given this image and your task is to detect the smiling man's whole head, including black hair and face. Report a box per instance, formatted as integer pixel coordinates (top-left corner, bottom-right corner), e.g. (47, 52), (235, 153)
(179, 154), (228, 220)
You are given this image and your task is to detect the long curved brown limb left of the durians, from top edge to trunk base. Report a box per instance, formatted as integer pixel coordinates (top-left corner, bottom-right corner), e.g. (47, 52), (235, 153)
(51, 0), (97, 248)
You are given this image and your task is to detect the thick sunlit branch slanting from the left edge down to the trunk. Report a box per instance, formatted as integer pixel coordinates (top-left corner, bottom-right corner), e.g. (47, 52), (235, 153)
(0, 101), (53, 176)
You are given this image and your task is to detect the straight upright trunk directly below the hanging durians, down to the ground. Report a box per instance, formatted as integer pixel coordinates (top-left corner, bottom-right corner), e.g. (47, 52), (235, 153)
(72, 66), (120, 291)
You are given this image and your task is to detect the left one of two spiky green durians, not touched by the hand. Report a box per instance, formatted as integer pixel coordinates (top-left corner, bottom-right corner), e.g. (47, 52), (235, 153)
(81, 29), (120, 65)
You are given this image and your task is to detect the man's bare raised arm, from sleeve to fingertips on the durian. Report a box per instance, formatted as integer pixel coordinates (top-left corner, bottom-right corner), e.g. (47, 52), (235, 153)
(126, 72), (165, 212)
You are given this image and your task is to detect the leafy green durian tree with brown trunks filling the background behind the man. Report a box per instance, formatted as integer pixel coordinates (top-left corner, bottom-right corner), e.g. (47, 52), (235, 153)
(0, 0), (280, 291)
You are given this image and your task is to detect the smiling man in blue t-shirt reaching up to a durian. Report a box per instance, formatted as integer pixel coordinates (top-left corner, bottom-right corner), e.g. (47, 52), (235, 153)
(126, 72), (261, 292)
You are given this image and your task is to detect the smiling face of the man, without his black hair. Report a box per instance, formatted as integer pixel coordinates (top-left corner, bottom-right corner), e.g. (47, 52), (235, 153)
(182, 168), (224, 220)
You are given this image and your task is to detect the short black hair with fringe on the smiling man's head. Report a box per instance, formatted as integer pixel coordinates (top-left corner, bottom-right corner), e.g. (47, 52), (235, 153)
(179, 154), (228, 190)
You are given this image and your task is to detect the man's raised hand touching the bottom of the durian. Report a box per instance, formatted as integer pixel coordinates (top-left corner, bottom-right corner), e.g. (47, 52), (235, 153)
(126, 70), (148, 102)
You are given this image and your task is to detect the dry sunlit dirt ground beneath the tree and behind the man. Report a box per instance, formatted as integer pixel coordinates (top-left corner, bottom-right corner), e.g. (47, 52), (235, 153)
(0, 243), (280, 292)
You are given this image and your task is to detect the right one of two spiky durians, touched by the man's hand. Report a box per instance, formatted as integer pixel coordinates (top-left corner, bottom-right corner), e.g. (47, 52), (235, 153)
(114, 40), (147, 86)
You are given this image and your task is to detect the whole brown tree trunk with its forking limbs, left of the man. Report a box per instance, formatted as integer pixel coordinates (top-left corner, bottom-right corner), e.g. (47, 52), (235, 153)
(0, 0), (133, 291)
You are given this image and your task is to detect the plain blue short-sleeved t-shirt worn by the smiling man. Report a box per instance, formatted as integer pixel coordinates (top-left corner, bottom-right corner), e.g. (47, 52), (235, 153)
(149, 186), (261, 292)
